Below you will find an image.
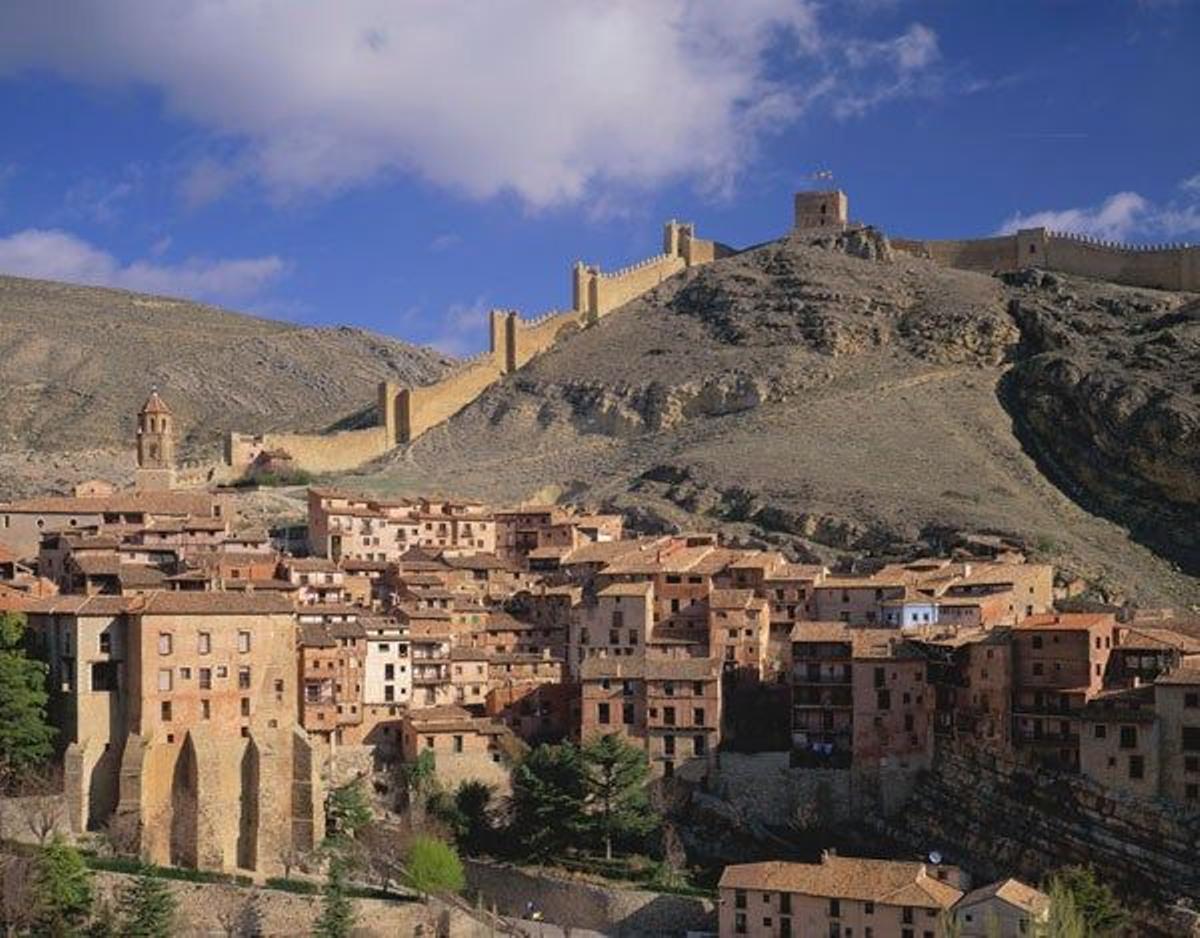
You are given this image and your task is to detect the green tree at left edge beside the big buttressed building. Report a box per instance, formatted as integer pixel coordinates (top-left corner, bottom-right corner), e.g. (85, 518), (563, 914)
(0, 613), (55, 781)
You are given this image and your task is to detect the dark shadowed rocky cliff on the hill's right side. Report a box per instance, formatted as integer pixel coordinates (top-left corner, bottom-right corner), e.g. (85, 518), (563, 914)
(1004, 273), (1200, 573)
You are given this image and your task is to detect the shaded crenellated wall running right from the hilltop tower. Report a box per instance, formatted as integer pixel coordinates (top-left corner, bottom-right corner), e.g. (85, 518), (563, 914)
(892, 228), (1200, 290)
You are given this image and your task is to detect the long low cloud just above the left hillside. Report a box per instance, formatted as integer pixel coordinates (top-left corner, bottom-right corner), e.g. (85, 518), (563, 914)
(0, 228), (287, 300)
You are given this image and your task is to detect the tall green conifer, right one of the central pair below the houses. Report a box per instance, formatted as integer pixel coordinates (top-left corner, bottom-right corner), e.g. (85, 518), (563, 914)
(581, 733), (658, 860)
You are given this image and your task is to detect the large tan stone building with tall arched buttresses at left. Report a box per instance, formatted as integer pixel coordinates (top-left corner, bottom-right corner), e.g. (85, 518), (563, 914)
(29, 591), (324, 871)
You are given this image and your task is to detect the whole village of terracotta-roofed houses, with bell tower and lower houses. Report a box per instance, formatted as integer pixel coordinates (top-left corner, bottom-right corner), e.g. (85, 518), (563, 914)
(0, 395), (1200, 938)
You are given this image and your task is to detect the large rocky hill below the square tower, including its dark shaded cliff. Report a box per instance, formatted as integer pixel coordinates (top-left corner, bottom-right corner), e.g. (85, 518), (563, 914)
(346, 234), (1200, 603)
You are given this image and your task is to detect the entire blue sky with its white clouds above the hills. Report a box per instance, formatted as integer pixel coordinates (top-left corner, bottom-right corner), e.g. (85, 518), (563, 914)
(0, 0), (1200, 354)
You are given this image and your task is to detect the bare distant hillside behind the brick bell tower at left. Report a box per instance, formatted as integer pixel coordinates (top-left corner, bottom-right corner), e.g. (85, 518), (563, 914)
(0, 276), (450, 497)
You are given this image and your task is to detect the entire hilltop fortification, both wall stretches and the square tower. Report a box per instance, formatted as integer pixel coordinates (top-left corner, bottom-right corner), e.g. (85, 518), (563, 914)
(222, 190), (1200, 477)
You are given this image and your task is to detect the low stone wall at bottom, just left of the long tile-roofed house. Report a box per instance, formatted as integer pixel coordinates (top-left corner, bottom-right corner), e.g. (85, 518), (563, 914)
(464, 860), (716, 936)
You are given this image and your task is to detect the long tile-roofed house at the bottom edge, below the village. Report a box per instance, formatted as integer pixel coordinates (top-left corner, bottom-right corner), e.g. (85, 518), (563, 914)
(718, 853), (962, 938)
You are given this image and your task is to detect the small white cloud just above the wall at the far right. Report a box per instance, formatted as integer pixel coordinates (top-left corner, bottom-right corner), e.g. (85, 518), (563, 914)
(998, 179), (1200, 241)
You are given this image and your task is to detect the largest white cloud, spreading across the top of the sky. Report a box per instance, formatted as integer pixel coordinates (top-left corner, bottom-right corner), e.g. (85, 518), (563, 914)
(0, 0), (937, 208)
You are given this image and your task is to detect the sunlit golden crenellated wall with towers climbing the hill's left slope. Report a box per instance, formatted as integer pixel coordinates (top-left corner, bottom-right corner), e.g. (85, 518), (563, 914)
(226, 221), (734, 473)
